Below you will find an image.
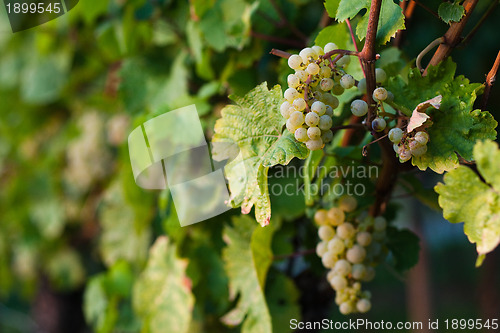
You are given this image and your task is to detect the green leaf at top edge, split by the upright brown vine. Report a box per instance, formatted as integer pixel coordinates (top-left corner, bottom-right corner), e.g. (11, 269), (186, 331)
(336, 0), (405, 44)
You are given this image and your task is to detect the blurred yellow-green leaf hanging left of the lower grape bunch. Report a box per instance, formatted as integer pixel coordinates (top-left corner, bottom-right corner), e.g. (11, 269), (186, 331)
(222, 216), (274, 333)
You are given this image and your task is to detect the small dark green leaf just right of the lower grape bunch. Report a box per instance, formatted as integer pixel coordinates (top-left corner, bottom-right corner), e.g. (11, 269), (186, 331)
(387, 228), (420, 272)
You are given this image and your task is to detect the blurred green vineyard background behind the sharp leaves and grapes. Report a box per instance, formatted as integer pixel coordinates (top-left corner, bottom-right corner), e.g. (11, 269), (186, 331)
(0, 0), (500, 333)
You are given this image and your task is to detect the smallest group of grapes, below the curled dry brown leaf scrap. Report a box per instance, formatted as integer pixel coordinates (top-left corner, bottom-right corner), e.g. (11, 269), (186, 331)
(389, 127), (429, 163)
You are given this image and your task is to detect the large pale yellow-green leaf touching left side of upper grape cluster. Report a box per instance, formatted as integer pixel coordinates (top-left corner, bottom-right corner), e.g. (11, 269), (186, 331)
(212, 82), (309, 225)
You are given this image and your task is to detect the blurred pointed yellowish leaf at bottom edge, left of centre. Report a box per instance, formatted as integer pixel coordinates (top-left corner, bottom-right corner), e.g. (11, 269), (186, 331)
(133, 236), (194, 333)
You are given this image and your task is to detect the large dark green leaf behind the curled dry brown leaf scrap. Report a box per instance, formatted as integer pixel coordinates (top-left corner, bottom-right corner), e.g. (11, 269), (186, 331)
(387, 58), (497, 173)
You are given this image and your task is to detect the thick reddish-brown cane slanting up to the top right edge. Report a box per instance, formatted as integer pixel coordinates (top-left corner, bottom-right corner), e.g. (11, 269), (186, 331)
(423, 0), (479, 76)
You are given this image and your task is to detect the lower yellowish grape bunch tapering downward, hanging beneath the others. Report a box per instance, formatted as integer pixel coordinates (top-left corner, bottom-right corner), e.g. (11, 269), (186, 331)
(314, 197), (387, 315)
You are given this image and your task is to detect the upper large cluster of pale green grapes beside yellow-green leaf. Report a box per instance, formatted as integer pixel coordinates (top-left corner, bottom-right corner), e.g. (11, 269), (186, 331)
(280, 43), (356, 150)
